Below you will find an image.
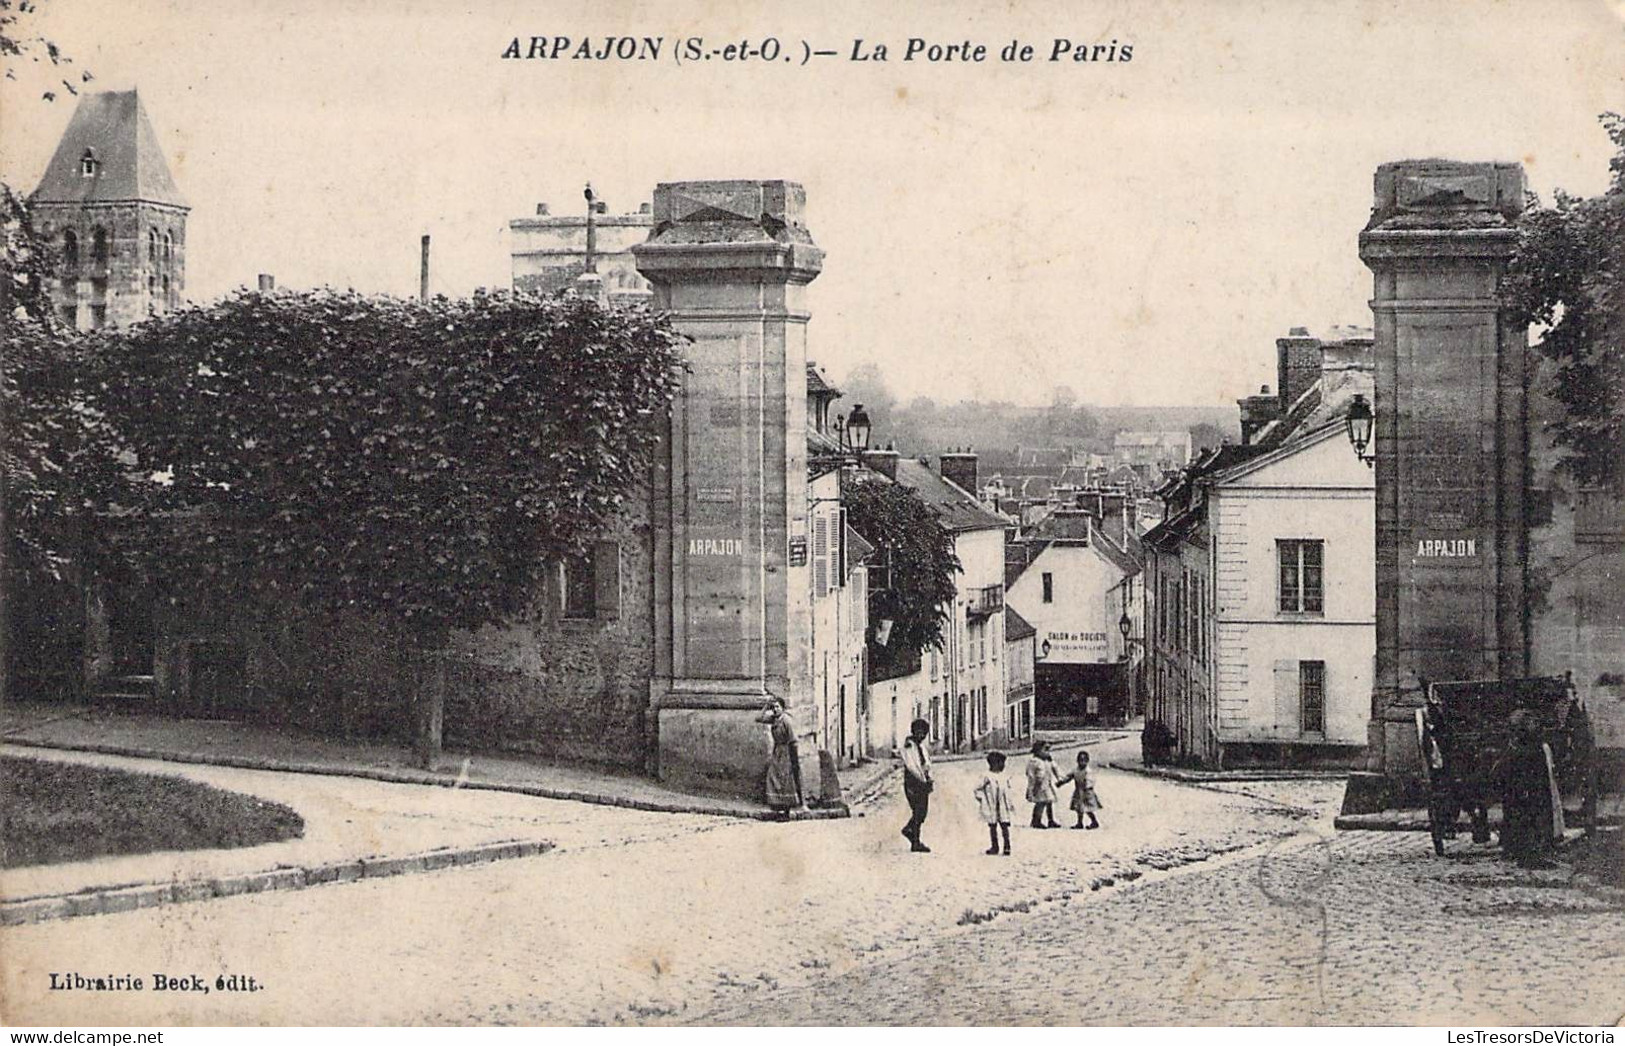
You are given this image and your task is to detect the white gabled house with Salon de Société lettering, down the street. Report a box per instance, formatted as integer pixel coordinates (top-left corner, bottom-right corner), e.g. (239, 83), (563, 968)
(1004, 510), (1141, 723)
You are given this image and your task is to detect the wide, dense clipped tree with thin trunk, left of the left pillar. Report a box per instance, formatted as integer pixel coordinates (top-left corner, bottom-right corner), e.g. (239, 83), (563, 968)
(93, 291), (683, 763)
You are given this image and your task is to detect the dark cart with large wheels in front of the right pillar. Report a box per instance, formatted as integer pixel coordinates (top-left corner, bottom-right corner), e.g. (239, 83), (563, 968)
(1415, 676), (1596, 854)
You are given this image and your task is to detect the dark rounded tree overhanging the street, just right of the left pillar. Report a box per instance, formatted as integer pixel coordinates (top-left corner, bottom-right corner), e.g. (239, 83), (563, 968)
(842, 473), (960, 679)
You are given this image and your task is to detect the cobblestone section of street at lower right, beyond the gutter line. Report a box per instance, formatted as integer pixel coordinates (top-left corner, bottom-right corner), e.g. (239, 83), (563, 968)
(694, 812), (1625, 1025)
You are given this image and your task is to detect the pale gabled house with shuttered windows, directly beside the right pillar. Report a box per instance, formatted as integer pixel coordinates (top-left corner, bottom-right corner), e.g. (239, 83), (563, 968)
(1144, 331), (1376, 767)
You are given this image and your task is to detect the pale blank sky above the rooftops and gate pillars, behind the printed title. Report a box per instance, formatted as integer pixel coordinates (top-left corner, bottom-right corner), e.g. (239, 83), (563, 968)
(0, 0), (1625, 404)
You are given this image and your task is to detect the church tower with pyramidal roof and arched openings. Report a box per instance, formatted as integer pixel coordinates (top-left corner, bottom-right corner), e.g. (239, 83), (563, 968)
(29, 91), (190, 330)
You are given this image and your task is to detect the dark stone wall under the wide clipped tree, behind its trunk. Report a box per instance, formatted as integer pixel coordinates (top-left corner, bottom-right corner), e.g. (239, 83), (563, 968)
(154, 492), (653, 770)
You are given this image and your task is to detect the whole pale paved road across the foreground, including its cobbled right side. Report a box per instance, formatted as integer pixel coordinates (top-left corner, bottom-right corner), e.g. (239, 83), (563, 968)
(0, 740), (1625, 1025)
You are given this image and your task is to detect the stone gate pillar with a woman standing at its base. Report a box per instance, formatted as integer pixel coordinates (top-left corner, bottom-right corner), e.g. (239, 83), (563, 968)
(632, 182), (824, 797)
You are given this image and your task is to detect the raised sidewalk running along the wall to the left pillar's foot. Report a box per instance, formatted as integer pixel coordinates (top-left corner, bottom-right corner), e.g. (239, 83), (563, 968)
(0, 702), (884, 820)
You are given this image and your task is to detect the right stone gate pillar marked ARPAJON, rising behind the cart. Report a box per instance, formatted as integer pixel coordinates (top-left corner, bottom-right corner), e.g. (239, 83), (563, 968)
(1344, 159), (1529, 814)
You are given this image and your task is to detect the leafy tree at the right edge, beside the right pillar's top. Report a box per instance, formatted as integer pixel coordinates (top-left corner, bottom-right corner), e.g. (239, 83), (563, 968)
(1503, 112), (1625, 486)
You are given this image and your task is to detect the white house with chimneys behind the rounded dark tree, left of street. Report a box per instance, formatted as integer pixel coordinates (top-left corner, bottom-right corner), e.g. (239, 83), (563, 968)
(863, 450), (1009, 752)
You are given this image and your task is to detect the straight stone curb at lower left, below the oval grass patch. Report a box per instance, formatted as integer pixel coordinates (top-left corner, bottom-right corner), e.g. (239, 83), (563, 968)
(0, 840), (553, 926)
